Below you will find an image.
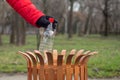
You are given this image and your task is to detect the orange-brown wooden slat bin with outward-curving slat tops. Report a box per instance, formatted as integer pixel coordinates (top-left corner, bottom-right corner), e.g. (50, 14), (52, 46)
(18, 50), (96, 80)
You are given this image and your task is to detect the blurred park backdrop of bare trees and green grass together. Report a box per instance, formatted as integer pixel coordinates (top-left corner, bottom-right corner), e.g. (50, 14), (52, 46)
(0, 0), (120, 77)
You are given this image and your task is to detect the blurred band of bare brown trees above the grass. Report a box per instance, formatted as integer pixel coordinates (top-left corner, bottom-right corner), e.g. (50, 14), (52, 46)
(0, 0), (120, 45)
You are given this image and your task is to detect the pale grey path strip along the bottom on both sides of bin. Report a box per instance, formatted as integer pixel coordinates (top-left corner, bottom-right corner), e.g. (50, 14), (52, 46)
(0, 73), (120, 80)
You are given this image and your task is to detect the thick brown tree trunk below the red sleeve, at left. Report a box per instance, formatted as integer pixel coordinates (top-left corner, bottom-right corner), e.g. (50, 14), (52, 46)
(10, 11), (26, 46)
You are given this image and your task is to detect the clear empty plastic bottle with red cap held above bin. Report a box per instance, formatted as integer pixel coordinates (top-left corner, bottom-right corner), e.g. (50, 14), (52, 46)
(39, 18), (55, 52)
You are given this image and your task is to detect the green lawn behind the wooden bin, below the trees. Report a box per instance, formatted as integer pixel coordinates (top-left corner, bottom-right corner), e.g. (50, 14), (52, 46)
(0, 35), (120, 78)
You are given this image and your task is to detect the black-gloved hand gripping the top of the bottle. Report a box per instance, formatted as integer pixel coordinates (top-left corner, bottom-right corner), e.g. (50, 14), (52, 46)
(36, 16), (58, 30)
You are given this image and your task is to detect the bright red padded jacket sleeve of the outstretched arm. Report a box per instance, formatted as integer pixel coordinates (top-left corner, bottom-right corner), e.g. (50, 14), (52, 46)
(6, 0), (44, 26)
